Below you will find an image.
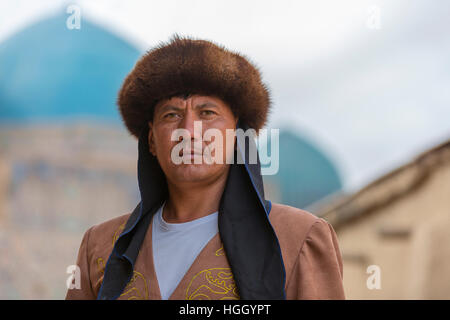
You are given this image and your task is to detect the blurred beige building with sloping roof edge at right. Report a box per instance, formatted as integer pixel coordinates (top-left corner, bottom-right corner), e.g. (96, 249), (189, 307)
(309, 140), (450, 299)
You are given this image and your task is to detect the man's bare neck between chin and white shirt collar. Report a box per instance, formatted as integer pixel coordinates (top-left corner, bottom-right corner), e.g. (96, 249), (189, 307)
(163, 170), (228, 223)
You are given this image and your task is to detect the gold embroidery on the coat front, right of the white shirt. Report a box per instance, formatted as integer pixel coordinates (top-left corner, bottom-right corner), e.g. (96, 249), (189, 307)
(186, 268), (239, 300)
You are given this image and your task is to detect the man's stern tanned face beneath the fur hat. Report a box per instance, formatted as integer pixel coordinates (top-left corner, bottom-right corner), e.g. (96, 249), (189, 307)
(148, 95), (237, 184)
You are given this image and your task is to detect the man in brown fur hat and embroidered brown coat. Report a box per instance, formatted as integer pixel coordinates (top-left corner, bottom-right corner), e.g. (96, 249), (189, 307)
(66, 36), (345, 300)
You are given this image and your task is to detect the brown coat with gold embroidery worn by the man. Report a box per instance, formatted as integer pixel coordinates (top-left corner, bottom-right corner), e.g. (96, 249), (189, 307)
(66, 203), (345, 300)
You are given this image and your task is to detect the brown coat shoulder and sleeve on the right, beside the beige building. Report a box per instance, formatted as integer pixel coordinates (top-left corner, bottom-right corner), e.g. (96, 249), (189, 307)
(269, 204), (345, 299)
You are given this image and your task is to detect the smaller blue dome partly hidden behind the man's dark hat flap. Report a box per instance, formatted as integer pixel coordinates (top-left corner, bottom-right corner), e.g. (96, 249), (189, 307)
(263, 130), (342, 208)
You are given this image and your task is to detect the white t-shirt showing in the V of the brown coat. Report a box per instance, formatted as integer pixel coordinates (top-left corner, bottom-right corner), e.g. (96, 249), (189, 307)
(152, 204), (219, 300)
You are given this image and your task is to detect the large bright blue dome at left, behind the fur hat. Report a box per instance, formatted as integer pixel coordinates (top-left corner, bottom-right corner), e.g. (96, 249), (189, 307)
(0, 15), (140, 121)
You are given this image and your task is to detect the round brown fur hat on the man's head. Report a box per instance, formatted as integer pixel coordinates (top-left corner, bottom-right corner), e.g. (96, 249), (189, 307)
(118, 35), (271, 137)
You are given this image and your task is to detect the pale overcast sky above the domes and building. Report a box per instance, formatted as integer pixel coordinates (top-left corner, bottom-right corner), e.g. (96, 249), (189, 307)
(0, 0), (450, 190)
